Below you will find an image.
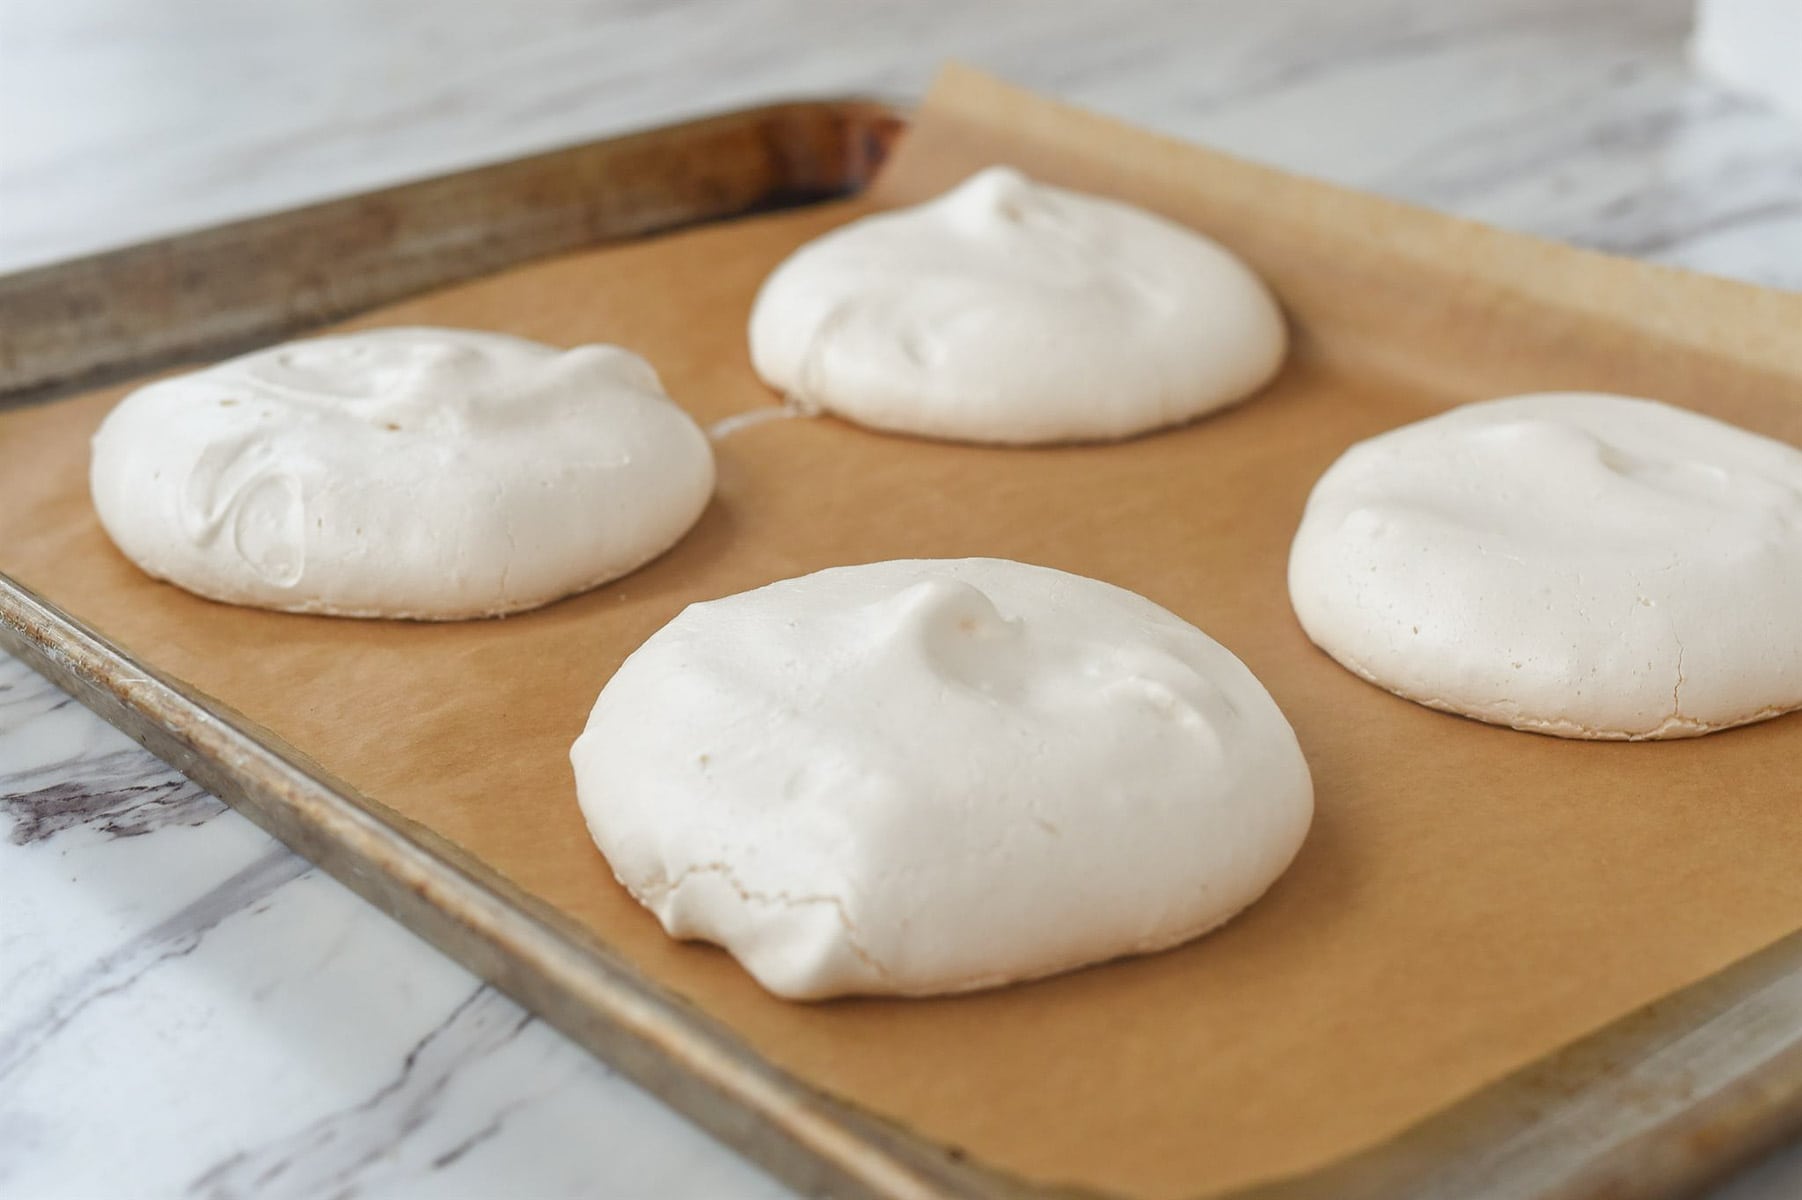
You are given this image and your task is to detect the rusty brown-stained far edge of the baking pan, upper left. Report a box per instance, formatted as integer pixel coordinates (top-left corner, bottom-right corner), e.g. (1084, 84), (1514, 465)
(0, 99), (903, 404)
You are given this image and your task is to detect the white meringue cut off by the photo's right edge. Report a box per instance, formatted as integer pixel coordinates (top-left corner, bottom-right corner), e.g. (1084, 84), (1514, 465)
(1288, 393), (1802, 741)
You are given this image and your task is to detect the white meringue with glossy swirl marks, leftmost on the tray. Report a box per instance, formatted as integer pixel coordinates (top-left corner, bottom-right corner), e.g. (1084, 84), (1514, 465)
(90, 328), (714, 620)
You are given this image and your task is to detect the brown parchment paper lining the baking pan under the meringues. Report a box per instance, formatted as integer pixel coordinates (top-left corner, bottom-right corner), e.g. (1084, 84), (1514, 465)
(0, 70), (1802, 1196)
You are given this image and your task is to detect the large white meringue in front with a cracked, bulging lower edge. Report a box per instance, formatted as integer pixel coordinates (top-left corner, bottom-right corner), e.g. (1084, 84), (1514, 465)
(571, 559), (1314, 998)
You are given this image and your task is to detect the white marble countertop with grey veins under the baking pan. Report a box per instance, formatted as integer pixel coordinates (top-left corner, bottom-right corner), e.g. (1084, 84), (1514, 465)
(0, 0), (1802, 1200)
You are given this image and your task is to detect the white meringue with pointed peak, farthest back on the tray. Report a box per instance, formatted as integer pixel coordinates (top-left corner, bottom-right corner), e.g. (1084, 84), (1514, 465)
(750, 168), (1287, 443)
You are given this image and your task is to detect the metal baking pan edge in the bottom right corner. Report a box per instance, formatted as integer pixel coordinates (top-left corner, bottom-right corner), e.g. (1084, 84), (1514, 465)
(1234, 918), (1802, 1200)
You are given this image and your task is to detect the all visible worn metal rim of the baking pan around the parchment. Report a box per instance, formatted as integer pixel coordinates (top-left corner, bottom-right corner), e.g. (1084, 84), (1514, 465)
(10, 99), (1802, 1200)
